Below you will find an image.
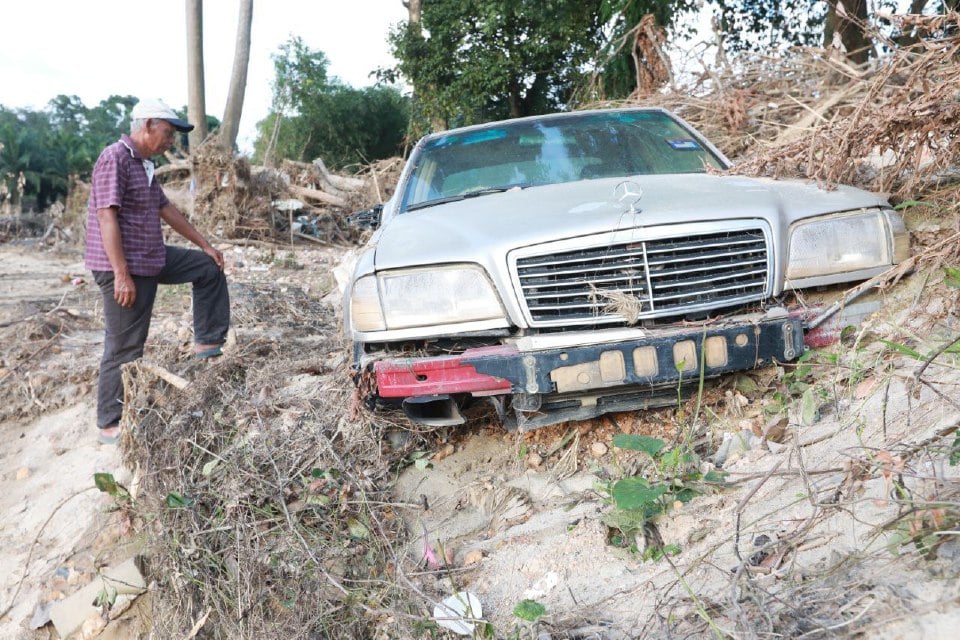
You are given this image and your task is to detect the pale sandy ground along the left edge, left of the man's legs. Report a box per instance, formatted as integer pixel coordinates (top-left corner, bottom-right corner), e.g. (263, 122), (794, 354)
(0, 244), (129, 638)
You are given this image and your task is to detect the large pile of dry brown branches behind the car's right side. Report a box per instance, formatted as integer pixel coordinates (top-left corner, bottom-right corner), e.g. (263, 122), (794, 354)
(628, 13), (960, 202)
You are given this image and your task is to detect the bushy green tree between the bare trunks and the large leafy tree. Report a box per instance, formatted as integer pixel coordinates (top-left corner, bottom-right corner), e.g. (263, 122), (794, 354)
(254, 37), (409, 169)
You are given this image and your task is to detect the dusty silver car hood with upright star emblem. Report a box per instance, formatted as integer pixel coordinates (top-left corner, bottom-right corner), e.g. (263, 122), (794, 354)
(375, 174), (886, 270)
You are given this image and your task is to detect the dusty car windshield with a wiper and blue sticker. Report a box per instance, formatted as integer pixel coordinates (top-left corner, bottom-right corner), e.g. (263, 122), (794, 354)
(401, 111), (722, 211)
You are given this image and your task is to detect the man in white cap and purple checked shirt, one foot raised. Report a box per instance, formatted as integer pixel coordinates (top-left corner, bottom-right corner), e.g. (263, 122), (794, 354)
(86, 99), (230, 444)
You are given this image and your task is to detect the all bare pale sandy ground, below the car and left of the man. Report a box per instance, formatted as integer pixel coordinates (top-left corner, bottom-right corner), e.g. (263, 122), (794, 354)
(0, 245), (960, 639)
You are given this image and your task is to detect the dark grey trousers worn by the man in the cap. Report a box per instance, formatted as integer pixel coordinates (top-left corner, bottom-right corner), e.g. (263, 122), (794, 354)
(93, 246), (230, 429)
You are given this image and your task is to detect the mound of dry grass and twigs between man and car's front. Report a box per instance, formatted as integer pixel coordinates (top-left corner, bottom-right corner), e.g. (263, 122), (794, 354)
(116, 302), (423, 639)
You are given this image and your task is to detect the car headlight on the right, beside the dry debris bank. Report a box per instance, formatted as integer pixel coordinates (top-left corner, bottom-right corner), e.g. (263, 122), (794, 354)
(786, 210), (909, 281)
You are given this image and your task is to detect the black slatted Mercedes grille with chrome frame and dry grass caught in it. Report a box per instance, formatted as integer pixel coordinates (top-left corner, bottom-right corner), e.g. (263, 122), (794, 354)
(517, 229), (768, 326)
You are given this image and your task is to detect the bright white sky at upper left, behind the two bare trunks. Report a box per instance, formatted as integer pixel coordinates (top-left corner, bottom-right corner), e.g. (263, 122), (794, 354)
(0, 0), (407, 153)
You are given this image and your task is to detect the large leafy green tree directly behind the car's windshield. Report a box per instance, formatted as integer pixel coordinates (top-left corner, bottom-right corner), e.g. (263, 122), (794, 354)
(390, 0), (602, 126)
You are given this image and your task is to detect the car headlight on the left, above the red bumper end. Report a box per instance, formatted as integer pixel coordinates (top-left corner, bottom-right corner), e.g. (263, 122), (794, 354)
(350, 265), (504, 331)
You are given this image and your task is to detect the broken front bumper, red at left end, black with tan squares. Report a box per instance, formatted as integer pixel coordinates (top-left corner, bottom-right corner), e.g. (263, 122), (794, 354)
(373, 317), (804, 398)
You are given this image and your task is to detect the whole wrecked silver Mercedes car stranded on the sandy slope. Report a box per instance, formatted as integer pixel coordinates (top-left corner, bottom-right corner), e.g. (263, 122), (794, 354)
(344, 109), (908, 429)
